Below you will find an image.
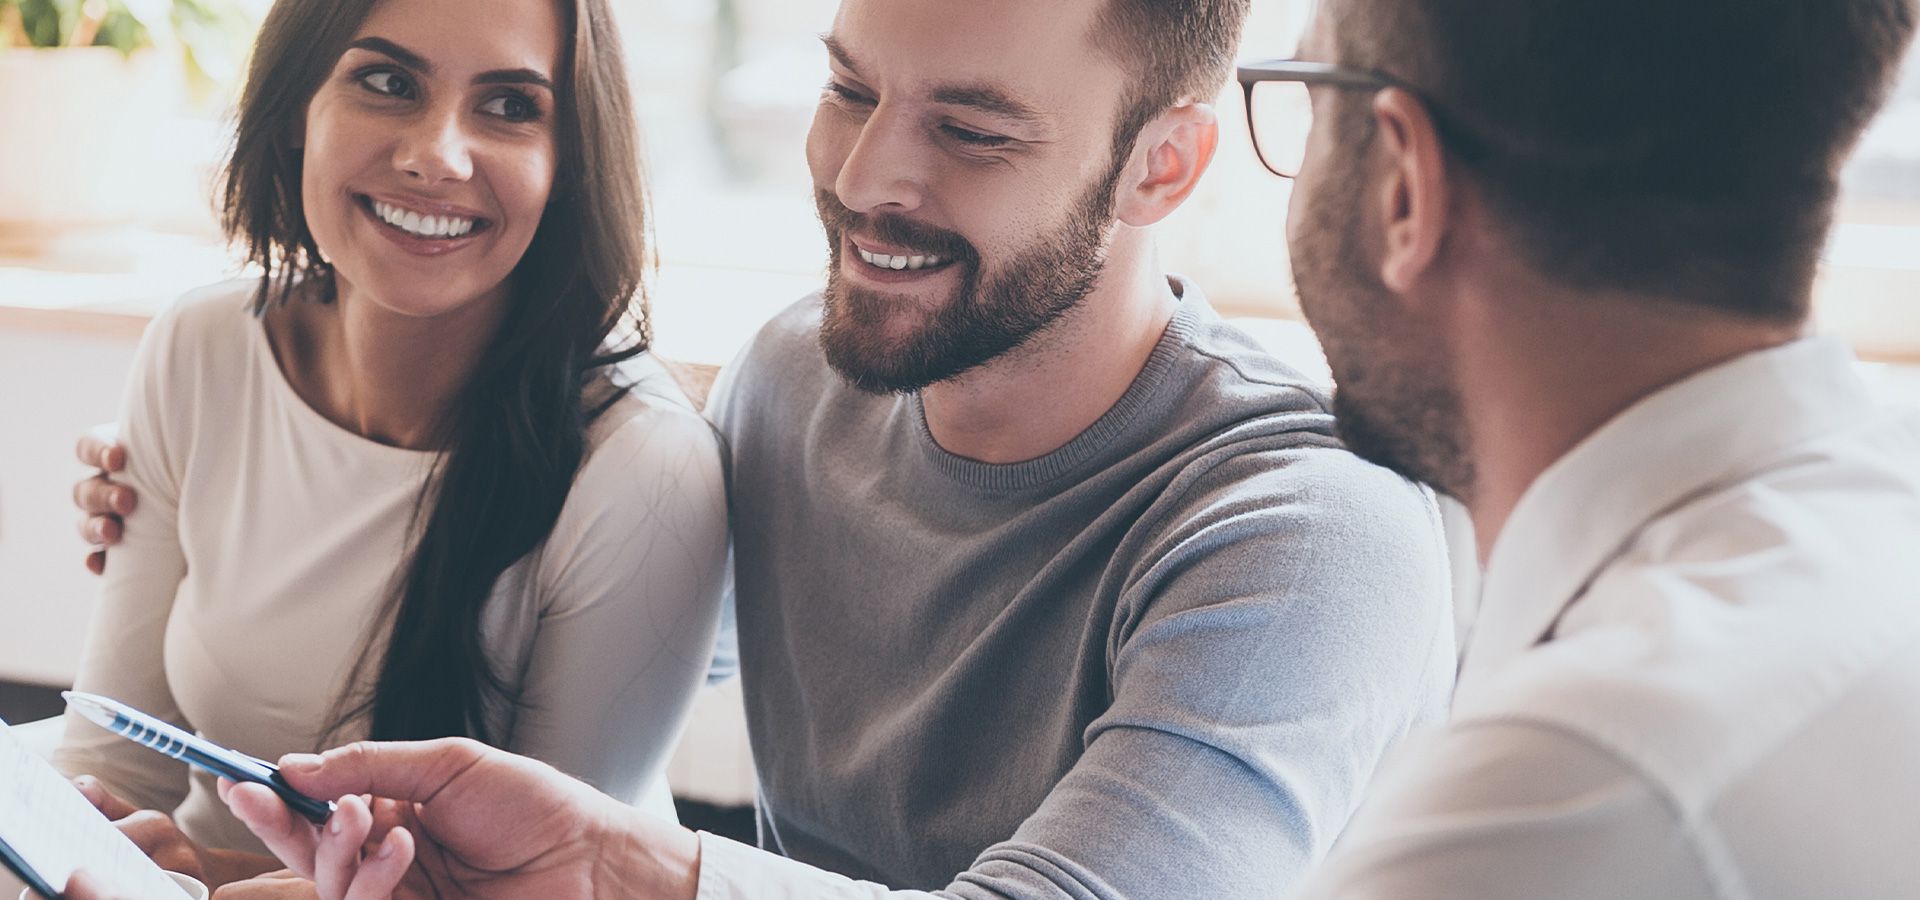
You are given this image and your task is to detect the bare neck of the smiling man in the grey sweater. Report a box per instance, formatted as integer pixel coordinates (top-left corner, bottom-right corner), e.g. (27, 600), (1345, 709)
(920, 230), (1179, 464)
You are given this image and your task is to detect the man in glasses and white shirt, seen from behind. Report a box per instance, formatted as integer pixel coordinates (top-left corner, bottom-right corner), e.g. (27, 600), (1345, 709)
(1240, 0), (1920, 900)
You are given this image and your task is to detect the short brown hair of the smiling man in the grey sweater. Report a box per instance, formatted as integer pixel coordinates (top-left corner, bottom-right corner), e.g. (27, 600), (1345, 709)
(1092, 0), (1250, 169)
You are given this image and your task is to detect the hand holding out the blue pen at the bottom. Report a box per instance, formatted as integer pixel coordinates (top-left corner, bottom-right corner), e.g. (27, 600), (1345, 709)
(221, 739), (699, 900)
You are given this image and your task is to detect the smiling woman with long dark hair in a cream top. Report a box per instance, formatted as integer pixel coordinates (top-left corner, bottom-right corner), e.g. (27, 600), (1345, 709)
(58, 0), (726, 881)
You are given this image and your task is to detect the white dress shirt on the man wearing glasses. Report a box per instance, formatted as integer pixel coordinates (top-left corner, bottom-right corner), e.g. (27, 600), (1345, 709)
(1306, 338), (1920, 900)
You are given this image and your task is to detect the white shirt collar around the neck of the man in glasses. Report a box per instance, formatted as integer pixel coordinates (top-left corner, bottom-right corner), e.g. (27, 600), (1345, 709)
(1459, 338), (1874, 699)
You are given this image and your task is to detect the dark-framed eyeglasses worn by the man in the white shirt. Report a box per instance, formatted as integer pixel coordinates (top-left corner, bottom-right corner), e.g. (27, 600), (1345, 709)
(1238, 59), (1488, 178)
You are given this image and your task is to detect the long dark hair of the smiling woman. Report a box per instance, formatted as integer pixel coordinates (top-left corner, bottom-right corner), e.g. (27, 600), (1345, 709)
(221, 0), (649, 741)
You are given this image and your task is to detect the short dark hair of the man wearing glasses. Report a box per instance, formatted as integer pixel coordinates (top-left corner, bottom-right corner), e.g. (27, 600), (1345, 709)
(1329, 0), (1914, 320)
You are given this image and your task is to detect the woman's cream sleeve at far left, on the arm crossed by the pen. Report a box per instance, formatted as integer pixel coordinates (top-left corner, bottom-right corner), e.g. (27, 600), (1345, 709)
(54, 301), (192, 814)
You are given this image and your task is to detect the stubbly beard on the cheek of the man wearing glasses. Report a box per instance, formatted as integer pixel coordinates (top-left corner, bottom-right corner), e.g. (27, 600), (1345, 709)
(1288, 144), (1475, 499)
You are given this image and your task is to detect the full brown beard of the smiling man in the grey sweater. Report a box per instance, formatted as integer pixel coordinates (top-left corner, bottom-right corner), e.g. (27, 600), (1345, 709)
(814, 173), (1119, 393)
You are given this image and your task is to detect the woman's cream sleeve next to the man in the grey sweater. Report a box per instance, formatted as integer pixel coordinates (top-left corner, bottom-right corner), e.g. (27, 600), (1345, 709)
(511, 397), (728, 802)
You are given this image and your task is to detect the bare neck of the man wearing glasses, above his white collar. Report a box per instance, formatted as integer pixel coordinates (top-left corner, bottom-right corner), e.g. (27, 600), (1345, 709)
(1453, 285), (1805, 564)
